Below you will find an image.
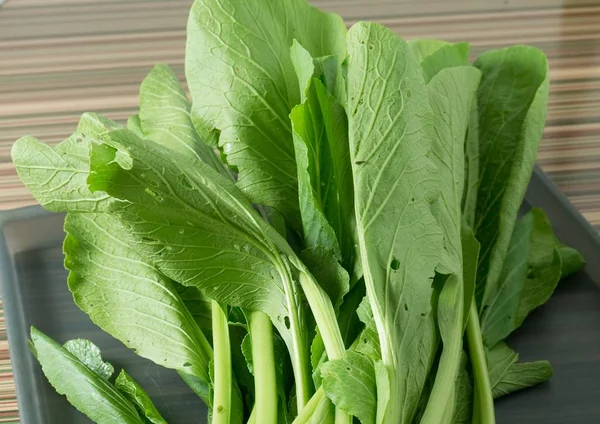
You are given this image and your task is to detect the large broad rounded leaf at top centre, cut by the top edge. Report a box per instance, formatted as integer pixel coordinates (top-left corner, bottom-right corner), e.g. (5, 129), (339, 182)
(185, 0), (346, 228)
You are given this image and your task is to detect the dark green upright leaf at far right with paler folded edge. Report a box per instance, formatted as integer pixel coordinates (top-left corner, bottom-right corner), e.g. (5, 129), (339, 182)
(474, 46), (548, 312)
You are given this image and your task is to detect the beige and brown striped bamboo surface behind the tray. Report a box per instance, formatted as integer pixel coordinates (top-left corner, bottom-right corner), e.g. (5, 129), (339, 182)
(0, 0), (600, 422)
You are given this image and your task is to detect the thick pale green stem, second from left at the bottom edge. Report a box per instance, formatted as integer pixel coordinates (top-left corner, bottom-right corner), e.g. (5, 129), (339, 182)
(250, 311), (277, 424)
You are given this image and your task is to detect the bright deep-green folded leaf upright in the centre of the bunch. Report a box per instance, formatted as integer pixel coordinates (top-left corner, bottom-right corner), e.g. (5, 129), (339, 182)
(290, 79), (354, 270)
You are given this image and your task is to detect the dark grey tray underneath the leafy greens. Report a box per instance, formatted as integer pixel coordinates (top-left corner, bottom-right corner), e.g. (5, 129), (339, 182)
(0, 169), (600, 424)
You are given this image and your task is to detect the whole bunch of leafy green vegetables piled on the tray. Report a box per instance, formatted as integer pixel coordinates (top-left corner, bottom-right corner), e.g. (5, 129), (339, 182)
(12, 0), (583, 424)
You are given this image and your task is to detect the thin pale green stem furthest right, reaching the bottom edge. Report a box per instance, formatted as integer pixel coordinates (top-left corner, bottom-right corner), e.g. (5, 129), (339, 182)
(467, 300), (496, 424)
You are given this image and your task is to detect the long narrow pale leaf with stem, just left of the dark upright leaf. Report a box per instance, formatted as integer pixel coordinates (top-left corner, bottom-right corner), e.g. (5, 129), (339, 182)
(421, 64), (480, 423)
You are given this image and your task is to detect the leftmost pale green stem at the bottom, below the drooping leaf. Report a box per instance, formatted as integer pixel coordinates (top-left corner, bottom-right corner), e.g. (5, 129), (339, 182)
(211, 300), (233, 424)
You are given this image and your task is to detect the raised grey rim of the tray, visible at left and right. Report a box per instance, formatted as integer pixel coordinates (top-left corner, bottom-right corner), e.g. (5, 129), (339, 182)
(0, 166), (600, 424)
